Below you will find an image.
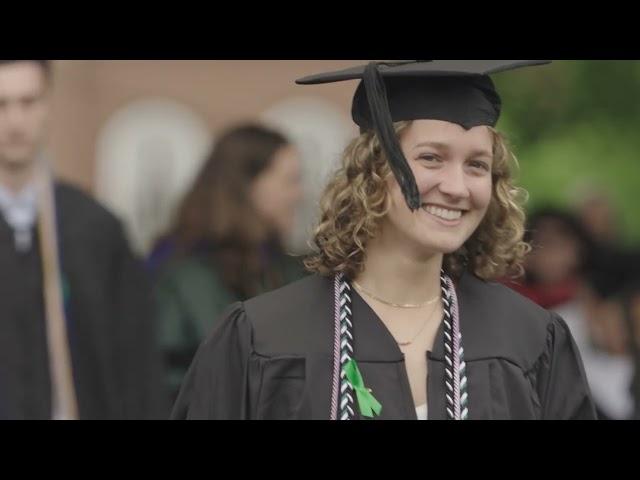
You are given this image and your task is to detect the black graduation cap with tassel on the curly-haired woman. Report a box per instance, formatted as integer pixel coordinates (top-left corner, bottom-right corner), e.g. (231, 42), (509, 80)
(296, 60), (550, 210)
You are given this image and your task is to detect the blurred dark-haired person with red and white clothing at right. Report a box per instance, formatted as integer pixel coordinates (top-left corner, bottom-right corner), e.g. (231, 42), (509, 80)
(510, 207), (634, 419)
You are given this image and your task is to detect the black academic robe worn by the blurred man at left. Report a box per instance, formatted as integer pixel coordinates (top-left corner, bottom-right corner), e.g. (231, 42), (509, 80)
(0, 184), (168, 419)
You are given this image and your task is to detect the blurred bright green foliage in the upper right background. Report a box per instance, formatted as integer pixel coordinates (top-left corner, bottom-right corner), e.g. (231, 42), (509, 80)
(495, 60), (640, 243)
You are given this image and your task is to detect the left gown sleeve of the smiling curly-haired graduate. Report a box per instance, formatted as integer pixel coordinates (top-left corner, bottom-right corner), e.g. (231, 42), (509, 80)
(171, 302), (252, 420)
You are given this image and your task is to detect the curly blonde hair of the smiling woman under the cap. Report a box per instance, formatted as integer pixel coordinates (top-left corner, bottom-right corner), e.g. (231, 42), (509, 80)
(304, 121), (530, 280)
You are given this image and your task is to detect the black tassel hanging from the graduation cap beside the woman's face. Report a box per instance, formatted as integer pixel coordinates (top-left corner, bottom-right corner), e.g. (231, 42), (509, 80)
(363, 62), (420, 211)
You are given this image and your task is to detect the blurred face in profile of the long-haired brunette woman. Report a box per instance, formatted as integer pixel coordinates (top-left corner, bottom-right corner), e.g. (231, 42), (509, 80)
(251, 146), (302, 238)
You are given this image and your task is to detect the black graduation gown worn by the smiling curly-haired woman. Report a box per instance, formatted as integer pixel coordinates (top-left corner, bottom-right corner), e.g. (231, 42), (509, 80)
(172, 274), (595, 419)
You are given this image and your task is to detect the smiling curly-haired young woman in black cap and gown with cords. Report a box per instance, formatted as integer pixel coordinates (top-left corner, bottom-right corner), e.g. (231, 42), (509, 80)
(173, 61), (595, 419)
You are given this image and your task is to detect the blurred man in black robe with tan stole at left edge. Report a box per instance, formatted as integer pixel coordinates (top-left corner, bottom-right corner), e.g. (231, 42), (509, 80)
(0, 60), (164, 419)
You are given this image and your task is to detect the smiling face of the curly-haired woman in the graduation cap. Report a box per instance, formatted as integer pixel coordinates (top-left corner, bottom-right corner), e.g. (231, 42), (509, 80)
(383, 120), (493, 255)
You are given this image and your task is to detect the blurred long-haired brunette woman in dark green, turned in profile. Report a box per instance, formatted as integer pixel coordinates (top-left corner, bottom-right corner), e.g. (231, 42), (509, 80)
(151, 124), (304, 398)
